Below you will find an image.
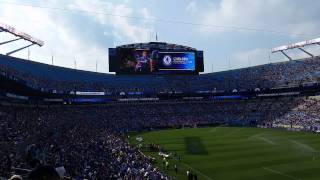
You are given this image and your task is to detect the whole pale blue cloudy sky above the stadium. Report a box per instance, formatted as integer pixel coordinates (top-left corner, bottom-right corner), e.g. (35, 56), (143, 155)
(0, 0), (320, 73)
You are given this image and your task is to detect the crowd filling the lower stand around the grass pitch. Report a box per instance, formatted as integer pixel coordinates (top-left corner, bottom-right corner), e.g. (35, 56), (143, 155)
(0, 97), (320, 179)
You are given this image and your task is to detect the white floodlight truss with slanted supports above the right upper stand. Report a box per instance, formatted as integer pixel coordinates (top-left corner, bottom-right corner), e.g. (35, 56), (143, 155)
(271, 38), (320, 60)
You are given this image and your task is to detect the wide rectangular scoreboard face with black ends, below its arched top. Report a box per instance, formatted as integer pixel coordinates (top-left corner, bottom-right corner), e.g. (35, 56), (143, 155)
(109, 48), (203, 74)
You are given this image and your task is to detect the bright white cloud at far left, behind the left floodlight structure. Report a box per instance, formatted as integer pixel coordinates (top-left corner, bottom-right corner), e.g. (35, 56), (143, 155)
(0, 1), (107, 72)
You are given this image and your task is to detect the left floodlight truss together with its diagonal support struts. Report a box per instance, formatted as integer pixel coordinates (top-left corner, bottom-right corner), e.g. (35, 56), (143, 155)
(0, 22), (44, 56)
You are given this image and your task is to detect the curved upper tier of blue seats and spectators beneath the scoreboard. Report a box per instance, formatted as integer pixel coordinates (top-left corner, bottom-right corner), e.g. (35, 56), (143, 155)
(0, 55), (320, 92)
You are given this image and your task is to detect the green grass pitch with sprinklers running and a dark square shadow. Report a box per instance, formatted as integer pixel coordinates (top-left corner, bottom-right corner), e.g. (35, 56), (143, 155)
(129, 127), (320, 180)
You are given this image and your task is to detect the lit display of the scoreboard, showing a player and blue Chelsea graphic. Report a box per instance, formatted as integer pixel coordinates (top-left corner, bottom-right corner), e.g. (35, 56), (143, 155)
(117, 48), (196, 74)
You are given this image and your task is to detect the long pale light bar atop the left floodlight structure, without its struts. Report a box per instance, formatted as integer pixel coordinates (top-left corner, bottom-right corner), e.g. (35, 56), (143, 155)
(0, 22), (44, 47)
